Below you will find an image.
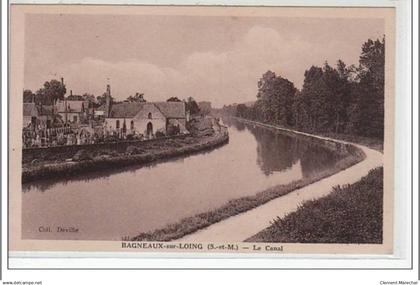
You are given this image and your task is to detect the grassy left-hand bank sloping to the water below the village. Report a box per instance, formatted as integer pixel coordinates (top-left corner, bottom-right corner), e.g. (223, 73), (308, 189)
(22, 132), (229, 183)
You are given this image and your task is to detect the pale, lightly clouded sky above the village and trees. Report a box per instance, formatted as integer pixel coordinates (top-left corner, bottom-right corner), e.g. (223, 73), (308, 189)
(24, 14), (384, 107)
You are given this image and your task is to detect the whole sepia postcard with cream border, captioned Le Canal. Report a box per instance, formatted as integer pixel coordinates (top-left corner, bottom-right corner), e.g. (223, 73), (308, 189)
(8, 5), (395, 254)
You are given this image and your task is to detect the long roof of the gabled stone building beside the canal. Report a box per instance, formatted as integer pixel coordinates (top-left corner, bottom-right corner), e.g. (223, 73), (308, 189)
(107, 102), (185, 118)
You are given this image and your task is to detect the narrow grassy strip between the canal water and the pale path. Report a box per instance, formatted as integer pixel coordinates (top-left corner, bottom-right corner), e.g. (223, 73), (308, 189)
(133, 118), (366, 241)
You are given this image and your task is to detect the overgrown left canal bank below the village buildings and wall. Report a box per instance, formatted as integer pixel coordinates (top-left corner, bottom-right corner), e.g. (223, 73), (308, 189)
(22, 128), (229, 183)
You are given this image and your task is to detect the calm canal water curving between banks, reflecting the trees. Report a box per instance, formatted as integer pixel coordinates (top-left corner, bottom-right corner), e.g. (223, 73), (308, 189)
(22, 117), (340, 240)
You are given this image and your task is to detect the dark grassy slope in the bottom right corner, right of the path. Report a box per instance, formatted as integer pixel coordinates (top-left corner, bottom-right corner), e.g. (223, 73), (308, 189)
(247, 167), (383, 243)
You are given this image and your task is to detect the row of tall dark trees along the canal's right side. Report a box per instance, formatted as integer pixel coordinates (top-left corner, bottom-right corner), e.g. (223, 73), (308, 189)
(230, 37), (385, 139)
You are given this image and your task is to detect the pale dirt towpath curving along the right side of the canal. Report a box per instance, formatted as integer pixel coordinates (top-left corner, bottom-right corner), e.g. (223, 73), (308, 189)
(177, 123), (383, 242)
